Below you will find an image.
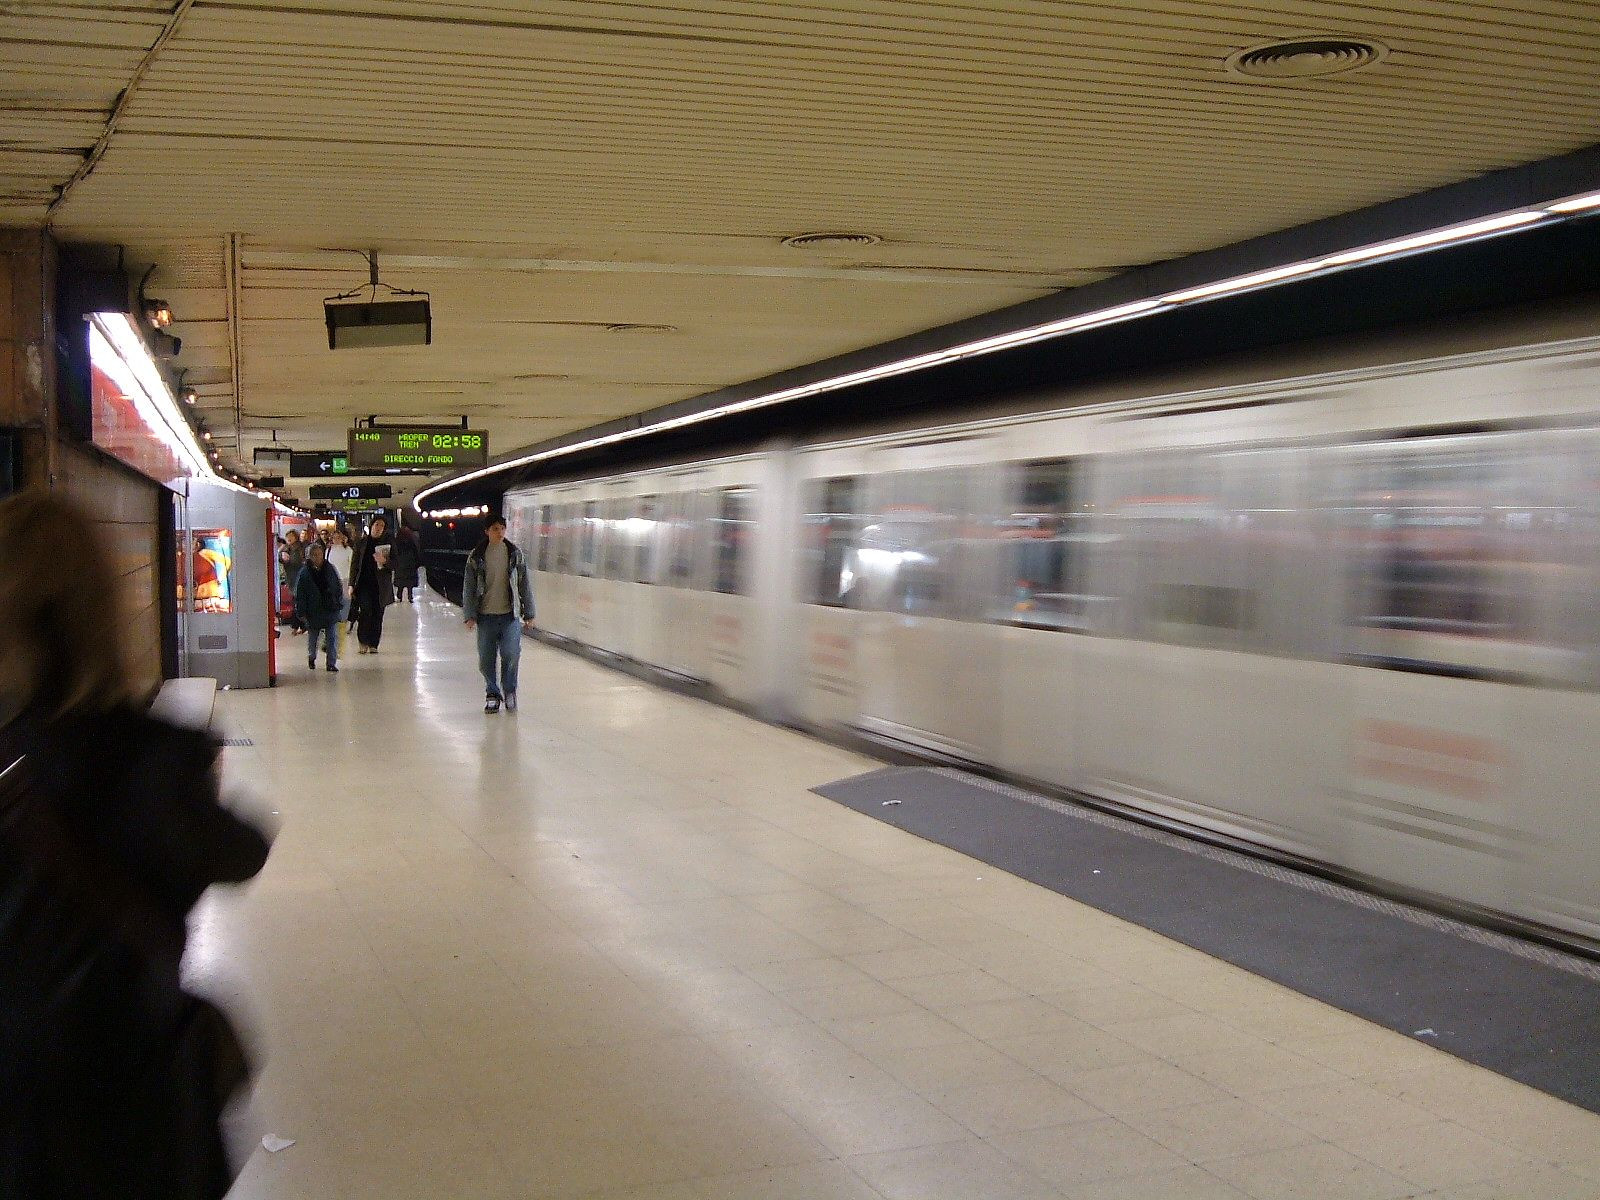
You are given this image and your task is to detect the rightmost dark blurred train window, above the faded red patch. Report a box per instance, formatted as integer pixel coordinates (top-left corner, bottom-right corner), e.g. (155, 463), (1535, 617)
(1338, 434), (1565, 675)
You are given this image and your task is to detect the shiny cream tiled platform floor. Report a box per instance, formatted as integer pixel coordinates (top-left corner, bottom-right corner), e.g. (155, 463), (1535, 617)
(194, 598), (1600, 1200)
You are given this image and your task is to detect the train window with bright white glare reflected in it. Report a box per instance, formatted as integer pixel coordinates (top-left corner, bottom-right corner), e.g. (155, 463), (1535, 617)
(846, 469), (966, 618)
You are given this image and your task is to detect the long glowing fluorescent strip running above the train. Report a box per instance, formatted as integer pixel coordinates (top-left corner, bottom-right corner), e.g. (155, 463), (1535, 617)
(411, 192), (1600, 512)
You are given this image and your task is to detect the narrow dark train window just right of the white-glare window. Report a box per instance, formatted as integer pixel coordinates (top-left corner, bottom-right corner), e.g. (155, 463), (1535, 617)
(989, 459), (1096, 629)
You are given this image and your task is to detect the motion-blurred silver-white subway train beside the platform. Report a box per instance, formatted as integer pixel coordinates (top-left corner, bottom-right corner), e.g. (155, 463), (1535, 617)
(504, 329), (1600, 949)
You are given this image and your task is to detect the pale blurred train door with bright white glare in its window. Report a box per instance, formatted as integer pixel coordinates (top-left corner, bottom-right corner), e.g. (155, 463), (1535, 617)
(854, 438), (1000, 762)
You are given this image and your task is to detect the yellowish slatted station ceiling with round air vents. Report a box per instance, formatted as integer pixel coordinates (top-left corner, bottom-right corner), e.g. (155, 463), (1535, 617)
(0, 0), (1600, 502)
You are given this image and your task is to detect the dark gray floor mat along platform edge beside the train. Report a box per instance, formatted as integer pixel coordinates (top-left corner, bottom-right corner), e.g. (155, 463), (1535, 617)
(814, 766), (1600, 1112)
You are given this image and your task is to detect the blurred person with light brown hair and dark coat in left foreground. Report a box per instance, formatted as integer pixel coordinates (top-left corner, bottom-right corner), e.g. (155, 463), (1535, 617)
(0, 493), (269, 1200)
